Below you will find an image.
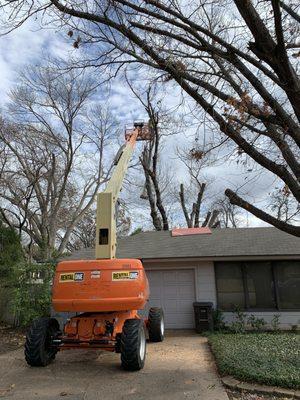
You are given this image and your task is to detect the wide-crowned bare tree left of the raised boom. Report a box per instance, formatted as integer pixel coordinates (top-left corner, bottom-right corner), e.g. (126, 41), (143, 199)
(0, 67), (116, 260)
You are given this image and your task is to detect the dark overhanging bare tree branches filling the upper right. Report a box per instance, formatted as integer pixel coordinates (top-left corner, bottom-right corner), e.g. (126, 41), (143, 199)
(2, 0), (300, 236)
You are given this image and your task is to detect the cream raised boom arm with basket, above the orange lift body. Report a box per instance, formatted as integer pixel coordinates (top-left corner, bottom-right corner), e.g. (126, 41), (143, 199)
(96, 123), (153, 259)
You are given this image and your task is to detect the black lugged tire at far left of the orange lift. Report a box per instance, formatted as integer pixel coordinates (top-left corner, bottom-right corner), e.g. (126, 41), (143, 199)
(24, 318), (59, 367)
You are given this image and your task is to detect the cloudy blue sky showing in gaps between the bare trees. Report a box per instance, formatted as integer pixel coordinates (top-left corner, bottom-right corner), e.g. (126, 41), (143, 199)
(0, 21), (273, 228)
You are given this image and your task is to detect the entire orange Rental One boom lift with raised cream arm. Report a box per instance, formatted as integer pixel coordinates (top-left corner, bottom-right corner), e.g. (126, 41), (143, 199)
(25, 123), (164, 370)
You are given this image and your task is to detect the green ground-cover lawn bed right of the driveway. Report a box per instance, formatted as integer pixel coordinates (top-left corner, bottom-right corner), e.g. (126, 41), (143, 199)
(208, 333), (300, 389)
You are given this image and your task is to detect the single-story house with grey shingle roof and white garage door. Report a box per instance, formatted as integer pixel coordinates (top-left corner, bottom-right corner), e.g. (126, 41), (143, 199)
(63, 228), (300, 329)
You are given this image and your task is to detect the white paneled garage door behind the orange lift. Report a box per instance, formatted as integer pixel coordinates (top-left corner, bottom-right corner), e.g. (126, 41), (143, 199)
(145, 269), (195, 329)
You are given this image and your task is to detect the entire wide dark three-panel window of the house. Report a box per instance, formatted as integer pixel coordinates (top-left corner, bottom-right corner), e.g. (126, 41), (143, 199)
(215, 261), (300, 310)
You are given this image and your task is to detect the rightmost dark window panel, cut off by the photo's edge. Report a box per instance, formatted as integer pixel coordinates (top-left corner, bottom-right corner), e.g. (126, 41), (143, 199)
(275, 261), (300, 310)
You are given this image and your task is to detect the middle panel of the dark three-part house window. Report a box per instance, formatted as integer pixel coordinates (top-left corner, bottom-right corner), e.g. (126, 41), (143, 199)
(245, 262), (276, 309)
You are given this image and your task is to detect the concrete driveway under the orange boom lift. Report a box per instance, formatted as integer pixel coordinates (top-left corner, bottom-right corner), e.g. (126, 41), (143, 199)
(0, 332), (228, 400)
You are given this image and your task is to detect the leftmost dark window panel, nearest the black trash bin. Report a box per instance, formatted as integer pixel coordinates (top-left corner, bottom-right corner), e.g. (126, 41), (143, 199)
(216, 262), (245, 310)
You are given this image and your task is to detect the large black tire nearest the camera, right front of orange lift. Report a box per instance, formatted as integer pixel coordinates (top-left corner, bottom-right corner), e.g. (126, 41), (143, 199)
(121, 319), (146, 371)
